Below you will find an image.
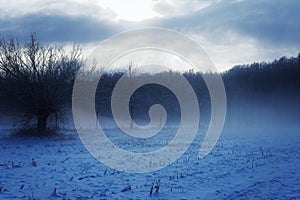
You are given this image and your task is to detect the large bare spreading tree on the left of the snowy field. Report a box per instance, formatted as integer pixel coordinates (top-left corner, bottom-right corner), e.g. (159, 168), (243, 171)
(0, 33), (82, 134)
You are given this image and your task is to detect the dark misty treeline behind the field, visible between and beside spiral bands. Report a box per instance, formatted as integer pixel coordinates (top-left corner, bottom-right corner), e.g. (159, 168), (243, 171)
(96, 54), (300, 133)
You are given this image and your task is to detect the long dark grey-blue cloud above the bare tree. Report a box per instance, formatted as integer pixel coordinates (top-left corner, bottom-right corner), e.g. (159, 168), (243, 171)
(0, 13), (120, 43)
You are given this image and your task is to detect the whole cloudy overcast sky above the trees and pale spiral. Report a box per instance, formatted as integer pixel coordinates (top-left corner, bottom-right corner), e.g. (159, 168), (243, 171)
(0, 0), (300, 70)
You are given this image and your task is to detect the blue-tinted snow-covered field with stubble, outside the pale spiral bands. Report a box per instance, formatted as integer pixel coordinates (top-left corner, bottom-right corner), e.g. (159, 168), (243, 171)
(0, 124), (300, 199)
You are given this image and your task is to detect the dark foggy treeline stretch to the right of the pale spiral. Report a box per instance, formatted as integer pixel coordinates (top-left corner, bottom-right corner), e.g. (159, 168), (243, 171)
(222, 54), (300, 131)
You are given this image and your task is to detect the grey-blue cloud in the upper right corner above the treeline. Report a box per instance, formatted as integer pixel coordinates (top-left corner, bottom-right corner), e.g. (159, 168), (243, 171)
(221, 0), (300, 47)
